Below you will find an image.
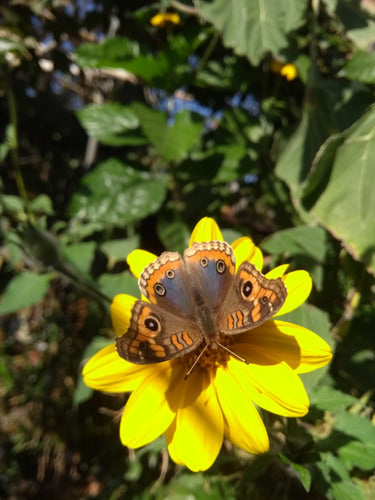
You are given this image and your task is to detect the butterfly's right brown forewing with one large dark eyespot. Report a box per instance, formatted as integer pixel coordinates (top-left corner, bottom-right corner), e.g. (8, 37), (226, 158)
(217, 262), (287, 335)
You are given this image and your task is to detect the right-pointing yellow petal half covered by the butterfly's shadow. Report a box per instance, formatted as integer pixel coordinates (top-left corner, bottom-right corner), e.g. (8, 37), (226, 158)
(233, 320), (332, 373)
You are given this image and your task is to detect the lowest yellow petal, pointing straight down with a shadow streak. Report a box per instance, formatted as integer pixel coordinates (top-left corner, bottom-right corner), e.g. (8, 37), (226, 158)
(165, 370), (224, 472)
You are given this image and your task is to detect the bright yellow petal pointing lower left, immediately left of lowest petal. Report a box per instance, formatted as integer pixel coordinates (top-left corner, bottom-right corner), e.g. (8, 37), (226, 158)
(120, 363), (175, 448)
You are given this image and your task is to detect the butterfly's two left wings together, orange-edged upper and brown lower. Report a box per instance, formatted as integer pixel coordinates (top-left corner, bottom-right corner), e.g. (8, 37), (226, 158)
(116, 252), (203, 364)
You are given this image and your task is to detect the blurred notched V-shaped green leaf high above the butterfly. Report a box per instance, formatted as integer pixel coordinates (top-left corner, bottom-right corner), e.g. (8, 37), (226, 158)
(132, 103), (202, 161)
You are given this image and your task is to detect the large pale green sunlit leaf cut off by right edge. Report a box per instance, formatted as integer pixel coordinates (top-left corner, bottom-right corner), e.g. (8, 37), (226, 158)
(311, 106), (375, 273)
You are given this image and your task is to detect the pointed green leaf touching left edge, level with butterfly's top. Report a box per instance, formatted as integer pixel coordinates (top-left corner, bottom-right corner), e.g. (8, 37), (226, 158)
(0, 271), (54, 315)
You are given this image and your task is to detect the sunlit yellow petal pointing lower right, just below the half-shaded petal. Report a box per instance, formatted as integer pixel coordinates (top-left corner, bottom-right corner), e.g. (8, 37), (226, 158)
(227, 356), (309, 417)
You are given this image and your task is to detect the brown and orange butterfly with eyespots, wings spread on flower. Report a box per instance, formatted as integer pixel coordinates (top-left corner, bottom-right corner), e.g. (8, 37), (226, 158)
(116, 241), (287, 364)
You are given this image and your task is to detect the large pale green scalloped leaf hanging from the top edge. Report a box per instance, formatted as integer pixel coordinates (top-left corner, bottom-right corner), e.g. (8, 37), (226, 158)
(197, 0), (308, 65)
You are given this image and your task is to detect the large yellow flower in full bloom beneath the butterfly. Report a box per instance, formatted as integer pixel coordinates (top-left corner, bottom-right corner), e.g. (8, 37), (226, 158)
(83, 218), (331, 471)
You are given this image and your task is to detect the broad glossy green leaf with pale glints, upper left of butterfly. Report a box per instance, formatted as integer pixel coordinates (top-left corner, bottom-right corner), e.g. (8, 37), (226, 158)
(68, 158), (166, 227)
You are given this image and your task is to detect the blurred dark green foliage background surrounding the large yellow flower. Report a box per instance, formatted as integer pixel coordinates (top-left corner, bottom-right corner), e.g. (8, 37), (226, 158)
(0, 0), (375, 500)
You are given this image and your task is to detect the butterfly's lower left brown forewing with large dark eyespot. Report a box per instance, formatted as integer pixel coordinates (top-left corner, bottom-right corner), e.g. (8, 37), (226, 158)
(116, 300), (203, 364)
